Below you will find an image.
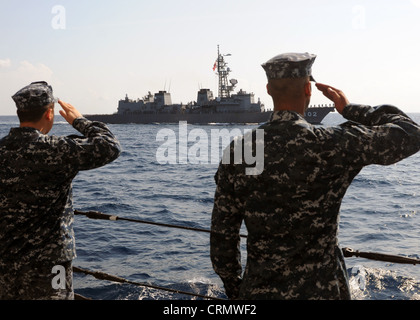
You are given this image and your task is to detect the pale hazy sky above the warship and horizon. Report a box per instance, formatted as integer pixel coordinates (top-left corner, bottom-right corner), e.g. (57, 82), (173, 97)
(0, 0), (420, 115)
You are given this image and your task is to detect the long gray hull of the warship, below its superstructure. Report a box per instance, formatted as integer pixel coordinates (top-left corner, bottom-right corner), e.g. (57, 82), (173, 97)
(85, 107), (334, 124)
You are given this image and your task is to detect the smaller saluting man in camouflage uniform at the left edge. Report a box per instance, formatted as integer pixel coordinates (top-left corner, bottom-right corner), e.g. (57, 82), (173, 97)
(0, 82), (121, 299)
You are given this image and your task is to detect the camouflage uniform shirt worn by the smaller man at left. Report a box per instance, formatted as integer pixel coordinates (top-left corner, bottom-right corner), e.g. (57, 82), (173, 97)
(0, 118), (121, 297)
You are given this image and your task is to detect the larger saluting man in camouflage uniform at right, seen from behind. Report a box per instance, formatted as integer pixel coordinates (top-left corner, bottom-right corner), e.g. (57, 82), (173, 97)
(210, 53), (420, 300)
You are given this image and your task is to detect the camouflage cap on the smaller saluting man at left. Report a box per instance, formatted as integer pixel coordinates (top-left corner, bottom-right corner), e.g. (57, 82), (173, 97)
(12, 81), (57, 111)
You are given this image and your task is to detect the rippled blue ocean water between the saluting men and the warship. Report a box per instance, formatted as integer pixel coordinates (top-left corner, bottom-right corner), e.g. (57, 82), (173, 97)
(0, 113), (420, 300)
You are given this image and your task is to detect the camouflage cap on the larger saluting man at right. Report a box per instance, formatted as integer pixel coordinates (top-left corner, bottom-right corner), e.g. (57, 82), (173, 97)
(262, 52), (316, 81)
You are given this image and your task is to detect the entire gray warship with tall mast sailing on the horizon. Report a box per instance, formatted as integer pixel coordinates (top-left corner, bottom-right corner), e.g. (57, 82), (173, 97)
(85, 46), (335, 124)
